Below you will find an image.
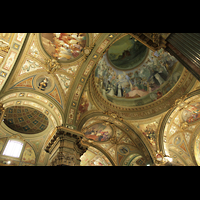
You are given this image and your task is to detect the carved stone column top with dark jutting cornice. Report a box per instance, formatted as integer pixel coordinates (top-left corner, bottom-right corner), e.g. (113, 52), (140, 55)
(45, 127), (88, 166)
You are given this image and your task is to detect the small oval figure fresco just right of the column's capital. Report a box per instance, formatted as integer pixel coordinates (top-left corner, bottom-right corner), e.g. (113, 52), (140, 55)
(84, 124), (112, 142)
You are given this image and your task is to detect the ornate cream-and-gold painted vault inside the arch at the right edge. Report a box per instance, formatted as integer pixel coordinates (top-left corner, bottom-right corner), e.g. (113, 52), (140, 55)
(163, 95), (200, 166)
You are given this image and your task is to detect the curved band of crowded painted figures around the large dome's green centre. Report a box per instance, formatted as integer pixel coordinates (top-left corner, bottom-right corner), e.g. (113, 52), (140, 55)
(95, 46), (180, 101)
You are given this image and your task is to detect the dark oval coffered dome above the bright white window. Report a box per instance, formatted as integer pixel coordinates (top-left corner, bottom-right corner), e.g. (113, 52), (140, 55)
(4, 106), (49, 134)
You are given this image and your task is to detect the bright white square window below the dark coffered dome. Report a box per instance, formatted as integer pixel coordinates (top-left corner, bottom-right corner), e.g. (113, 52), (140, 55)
(3, 140), (23, 158)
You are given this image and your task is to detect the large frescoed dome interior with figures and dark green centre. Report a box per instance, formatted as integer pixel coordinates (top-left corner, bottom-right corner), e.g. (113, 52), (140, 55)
(94, 35), (184, 107)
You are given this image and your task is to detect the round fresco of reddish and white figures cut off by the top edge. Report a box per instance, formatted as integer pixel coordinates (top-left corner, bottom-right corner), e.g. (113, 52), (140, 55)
(41, 33), (86, 61)
